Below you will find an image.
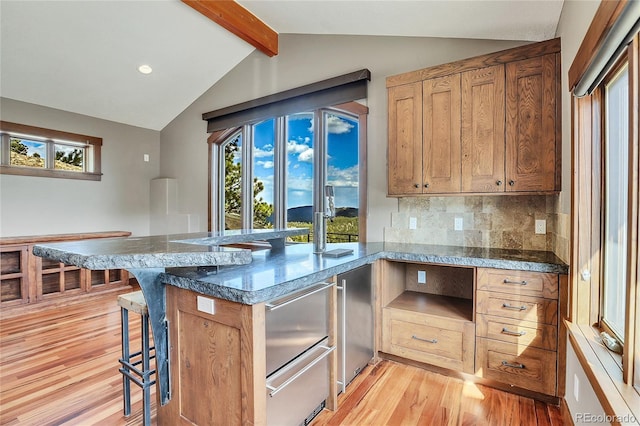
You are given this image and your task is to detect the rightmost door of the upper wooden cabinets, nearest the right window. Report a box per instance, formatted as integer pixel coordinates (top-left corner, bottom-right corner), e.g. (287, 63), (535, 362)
(506, 54), (559, 191)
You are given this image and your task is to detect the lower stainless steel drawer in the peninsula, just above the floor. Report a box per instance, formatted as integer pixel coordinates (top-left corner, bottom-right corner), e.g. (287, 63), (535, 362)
(266, 339), (335, 426)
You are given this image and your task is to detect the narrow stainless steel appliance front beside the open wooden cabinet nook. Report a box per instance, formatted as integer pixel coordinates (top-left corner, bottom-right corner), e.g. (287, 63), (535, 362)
(337, 265), (373, 392)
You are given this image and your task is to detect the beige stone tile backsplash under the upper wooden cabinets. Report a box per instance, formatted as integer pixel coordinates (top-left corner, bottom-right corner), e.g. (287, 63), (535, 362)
(384, 195), (569, 255)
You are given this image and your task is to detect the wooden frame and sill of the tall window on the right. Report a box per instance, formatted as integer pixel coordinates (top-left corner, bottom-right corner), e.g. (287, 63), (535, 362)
(564, 18), (640, 419)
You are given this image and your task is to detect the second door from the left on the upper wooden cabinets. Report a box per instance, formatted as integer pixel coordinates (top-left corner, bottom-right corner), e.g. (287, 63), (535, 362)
(422, 74), (461, 193)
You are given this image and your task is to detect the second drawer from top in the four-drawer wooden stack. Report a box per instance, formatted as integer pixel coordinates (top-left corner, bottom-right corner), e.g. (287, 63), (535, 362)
(476, 291), (558, 325)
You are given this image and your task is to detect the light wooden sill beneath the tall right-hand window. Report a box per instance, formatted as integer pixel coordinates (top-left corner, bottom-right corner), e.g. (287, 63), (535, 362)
(565, 321), (640, 424)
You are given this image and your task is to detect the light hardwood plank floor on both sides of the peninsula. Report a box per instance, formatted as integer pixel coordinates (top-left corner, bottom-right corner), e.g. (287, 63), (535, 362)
(0, 294), (562, 426)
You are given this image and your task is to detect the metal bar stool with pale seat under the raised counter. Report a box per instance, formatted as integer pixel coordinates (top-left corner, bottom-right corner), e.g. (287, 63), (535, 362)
(118, 291), (156, 426)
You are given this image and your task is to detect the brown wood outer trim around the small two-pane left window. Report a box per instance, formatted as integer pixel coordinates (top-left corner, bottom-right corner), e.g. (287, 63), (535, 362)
(0, 121), (102, 181)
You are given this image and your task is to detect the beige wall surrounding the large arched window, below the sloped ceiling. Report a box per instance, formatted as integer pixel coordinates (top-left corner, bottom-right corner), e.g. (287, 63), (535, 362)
(160, 34), (524, 241)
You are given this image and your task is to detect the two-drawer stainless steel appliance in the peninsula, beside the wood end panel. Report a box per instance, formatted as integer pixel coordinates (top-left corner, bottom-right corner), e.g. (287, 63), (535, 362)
(265, 283), (335, 426)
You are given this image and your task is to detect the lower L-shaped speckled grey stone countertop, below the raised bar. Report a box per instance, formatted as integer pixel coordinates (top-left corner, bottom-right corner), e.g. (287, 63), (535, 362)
(161, 243), (568, 304)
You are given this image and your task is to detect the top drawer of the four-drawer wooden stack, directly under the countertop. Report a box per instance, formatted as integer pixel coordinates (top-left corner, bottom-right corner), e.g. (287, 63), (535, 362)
(477, 268), (558, 299)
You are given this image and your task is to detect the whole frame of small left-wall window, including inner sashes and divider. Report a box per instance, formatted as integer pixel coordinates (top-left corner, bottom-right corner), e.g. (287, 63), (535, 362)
(0, 121), (102, 181)
